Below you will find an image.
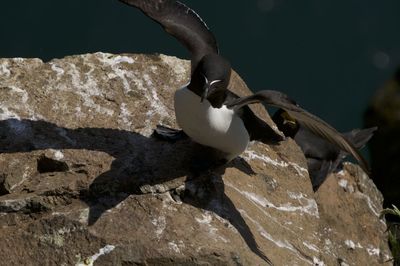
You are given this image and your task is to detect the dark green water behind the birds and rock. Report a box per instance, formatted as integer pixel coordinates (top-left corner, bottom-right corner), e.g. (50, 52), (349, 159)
(0, 0), (400, 130)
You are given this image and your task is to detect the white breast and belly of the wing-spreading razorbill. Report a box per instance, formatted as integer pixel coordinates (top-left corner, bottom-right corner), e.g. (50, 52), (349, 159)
(175, 87), (250, 160)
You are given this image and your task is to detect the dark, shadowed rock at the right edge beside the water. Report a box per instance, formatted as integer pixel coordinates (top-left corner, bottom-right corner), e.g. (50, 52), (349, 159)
(364, 68), (400, 207)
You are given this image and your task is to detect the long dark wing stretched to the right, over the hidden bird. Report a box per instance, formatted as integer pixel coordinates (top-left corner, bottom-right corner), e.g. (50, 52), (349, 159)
(227, 90), (369, 173)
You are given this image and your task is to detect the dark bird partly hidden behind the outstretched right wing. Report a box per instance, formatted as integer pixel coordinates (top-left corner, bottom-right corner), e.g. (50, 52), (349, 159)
(272, 109), (378, 191)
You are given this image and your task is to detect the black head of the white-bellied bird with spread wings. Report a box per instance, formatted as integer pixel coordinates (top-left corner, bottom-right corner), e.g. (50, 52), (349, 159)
(192, 54), (231, 103)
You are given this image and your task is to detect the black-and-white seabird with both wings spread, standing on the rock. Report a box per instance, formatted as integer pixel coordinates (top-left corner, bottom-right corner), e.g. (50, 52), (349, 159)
(120, 0), (368, 175)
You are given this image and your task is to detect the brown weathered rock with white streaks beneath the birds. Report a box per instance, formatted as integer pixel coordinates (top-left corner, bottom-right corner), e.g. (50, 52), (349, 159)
(0, 53), (390, 265)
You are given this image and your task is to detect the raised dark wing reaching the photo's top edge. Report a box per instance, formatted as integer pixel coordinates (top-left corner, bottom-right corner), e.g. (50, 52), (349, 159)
(119, 0), (218, 71)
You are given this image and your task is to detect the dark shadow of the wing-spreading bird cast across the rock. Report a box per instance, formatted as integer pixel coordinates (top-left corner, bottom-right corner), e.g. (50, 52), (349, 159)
(0, 119), (268, 261)
